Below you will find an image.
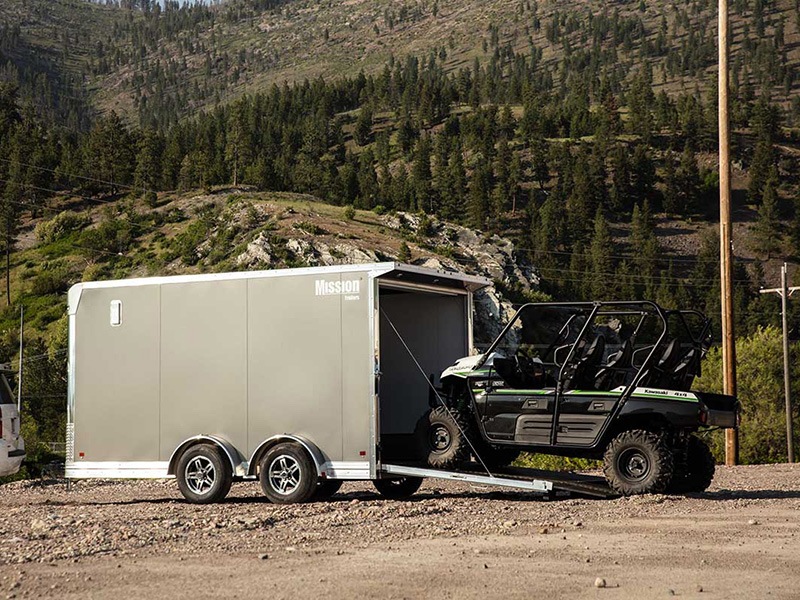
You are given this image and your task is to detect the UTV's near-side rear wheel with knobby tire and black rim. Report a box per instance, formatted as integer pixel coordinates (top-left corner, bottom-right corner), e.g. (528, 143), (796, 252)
(603, 429), (673, 496)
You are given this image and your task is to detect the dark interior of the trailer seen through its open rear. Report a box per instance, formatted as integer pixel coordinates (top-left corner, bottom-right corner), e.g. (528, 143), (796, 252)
(379, 286), (470, 458)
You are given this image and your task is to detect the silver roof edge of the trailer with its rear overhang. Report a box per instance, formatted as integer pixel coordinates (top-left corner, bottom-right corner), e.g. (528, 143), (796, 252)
(69, 262), (492, 312)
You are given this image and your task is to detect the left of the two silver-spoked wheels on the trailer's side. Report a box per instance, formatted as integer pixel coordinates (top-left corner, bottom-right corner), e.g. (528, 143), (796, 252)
(176, 444), (233, 504)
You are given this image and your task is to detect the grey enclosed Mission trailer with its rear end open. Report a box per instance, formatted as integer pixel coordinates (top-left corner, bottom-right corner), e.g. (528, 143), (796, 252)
(66, 262), (564, 502)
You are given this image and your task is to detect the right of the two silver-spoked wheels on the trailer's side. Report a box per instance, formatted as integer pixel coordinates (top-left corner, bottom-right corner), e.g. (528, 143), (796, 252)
(258, 442), (317, 504)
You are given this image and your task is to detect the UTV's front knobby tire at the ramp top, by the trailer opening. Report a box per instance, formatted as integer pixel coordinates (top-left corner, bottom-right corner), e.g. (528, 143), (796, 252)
(414, 406), (469, 469)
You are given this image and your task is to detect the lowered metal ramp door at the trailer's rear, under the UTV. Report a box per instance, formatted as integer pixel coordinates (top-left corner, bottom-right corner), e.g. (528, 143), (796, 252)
(382, 463), (616, 498)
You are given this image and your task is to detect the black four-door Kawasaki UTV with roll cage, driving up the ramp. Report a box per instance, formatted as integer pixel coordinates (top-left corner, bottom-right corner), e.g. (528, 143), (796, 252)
(417, 302), (738, 495)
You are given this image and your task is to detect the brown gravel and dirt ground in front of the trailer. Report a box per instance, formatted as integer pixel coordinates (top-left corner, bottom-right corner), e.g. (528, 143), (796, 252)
(0, 465), (800, 598)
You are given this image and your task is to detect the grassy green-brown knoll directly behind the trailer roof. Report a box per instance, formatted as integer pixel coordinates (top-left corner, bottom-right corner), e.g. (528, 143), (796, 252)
(0, 190), (472, 337)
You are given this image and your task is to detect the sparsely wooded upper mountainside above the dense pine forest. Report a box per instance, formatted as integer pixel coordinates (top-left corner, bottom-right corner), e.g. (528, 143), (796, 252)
(0, 0), (800, 124)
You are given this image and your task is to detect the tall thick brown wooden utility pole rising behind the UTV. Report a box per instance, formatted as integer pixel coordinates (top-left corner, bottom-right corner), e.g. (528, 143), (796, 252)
(718, 0), (739, 465)
